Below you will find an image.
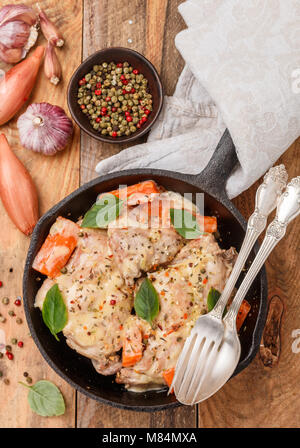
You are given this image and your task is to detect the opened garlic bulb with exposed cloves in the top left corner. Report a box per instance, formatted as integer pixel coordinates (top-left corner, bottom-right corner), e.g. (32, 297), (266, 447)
(0, 4), (38, 64)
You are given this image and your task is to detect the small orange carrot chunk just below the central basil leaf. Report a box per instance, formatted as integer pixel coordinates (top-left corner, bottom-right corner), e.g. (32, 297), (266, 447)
(122, 326), (143, 367)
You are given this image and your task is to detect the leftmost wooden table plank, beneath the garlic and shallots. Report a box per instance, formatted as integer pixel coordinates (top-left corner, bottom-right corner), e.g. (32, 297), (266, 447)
(0, 0), (82, 428)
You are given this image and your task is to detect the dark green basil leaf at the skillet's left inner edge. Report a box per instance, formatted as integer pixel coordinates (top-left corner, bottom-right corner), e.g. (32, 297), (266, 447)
(42, 284), (68, 341)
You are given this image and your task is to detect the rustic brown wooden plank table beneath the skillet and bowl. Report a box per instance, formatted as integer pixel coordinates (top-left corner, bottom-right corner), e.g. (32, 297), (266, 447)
(0, 0), (300, 428)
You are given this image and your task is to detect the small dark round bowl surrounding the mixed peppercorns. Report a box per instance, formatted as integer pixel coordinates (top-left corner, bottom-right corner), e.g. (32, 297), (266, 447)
(68, 47), (163, 143)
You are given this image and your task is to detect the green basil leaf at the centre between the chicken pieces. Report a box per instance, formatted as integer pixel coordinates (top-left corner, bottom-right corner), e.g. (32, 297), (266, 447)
(134, 278), (159, 325)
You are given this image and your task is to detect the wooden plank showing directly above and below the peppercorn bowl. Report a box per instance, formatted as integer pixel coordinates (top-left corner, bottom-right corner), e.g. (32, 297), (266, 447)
(80, 0), (146, 184)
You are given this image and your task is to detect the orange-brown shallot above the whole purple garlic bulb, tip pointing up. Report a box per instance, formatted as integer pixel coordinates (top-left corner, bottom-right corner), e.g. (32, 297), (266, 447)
(0, 46), (45, 126)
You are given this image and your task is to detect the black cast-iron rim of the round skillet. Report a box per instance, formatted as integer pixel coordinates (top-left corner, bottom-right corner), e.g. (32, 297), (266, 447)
(23, 168), (267, 412)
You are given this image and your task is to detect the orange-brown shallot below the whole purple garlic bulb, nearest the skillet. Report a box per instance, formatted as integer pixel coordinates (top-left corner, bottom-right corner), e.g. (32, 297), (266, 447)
(0, 134), (39, 235)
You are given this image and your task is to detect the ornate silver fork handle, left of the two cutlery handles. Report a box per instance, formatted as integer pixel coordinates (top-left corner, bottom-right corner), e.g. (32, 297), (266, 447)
(211, 165), (288, 319)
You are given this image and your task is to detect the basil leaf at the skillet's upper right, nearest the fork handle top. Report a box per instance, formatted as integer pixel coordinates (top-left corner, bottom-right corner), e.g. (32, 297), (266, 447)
(170, 208), (204, 240)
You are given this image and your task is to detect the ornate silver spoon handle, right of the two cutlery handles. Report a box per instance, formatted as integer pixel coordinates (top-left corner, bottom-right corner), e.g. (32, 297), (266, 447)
(224, 176), (300, 329)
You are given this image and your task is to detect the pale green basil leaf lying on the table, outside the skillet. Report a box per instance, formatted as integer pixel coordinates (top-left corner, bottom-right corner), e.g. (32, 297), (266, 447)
(19, 380), (66, 417)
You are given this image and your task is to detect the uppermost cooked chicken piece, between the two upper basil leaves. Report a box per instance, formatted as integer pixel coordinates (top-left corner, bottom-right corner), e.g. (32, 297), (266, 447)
(108, 192), (194, 285)
